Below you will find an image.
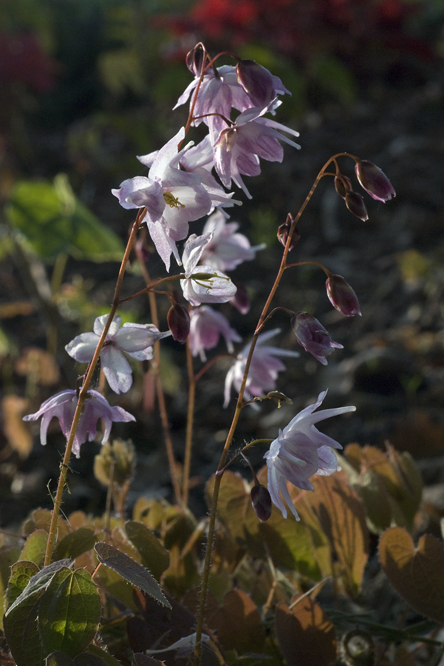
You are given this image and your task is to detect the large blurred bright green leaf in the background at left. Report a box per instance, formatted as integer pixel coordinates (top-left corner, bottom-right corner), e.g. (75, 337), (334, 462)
(6, 174), (123, 262)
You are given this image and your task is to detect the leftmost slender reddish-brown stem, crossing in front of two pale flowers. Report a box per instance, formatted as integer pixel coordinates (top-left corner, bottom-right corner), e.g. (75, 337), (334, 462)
(44, 208), (145, 566)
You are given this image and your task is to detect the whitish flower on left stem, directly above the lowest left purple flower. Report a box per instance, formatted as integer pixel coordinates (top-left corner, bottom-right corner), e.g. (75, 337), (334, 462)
(65, 315), (171, 393)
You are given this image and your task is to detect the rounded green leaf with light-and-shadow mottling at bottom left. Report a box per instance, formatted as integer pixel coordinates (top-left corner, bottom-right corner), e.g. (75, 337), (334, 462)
(39, 567), (101, 657)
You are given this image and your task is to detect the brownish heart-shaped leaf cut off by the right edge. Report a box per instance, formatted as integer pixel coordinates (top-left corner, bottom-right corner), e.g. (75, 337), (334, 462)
(379, 527), (444, 624)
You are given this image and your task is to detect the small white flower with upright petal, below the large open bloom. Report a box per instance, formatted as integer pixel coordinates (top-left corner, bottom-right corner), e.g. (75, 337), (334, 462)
(180, 234), (236, 305)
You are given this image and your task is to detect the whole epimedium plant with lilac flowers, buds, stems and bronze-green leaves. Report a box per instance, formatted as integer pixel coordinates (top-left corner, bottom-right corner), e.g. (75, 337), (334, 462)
(0, 44), (438, 666)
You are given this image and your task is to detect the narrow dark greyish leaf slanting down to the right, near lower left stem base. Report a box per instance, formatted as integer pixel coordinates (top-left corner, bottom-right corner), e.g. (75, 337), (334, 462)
(95, 543), (171, 608)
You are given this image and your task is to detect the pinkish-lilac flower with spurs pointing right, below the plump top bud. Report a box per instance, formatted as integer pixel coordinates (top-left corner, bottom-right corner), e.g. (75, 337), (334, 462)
(214, 100), (300, 199)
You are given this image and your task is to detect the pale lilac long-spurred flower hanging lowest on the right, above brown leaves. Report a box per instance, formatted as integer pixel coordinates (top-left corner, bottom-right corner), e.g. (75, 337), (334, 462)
(264, 391), (356, 520)
